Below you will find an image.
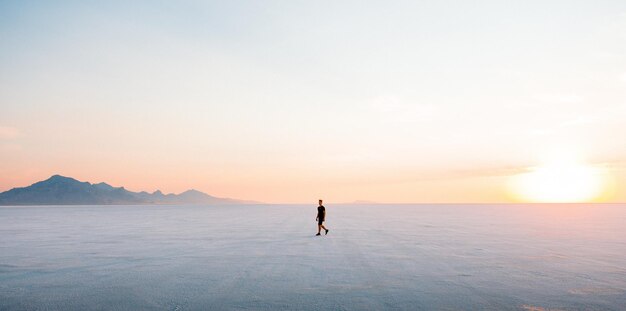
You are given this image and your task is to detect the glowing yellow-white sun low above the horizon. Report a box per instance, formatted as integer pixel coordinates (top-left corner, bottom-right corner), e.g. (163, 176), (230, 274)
(512, 155), (604, 203)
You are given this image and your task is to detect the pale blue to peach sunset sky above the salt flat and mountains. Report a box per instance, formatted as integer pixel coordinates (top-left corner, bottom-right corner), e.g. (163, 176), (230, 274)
(0, 0), (626, 204)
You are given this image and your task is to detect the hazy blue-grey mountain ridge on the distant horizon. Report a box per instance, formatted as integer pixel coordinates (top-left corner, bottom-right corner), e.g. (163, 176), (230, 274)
(0, 175), (259, 205)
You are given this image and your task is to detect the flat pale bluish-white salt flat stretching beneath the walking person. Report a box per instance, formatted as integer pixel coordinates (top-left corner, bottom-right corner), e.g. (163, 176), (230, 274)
(0, 202), (626, 310)
